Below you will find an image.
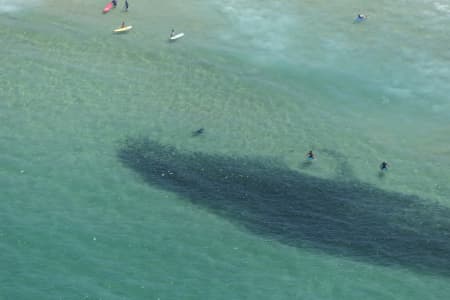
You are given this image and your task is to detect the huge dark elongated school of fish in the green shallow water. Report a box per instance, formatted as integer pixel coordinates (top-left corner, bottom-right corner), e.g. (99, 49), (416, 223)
(118, 139), (450, 276)
